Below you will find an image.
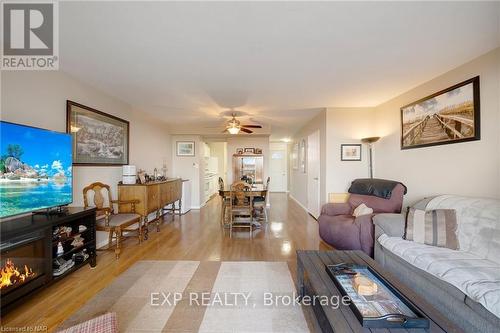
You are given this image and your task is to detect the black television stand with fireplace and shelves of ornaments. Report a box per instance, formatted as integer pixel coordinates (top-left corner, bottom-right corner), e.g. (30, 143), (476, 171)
(0, 207), (96, 313)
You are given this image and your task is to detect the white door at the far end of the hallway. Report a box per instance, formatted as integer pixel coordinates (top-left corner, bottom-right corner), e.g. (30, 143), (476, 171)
(270, 143), (288, 192)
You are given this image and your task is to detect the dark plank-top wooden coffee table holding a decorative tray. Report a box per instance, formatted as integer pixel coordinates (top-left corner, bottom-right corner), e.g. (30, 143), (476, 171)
(297, 251), (463, 333)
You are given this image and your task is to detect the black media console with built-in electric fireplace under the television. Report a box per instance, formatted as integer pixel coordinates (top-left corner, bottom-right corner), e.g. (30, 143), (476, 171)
(0, 207), (96, 314)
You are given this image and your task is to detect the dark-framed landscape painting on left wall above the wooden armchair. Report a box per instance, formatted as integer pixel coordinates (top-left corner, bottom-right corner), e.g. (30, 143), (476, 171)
(66, 101), (129, 166)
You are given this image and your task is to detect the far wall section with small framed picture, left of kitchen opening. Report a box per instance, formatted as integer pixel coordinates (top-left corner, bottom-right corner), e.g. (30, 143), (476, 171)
(172, 135), (205, 209)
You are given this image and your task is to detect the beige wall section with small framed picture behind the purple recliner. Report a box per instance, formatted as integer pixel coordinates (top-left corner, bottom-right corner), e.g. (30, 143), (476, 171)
(326, 108), (376, 195)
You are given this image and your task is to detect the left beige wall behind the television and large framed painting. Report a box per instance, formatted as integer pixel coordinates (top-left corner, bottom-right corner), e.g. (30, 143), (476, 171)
(1, 71), (171, 206)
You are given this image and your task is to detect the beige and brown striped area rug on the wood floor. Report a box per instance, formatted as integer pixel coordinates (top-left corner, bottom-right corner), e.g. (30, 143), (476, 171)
(59, 261), (309, 332)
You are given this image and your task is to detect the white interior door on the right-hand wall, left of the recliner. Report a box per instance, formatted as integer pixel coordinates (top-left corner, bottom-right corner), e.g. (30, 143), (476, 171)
(306, 131), (321, 218)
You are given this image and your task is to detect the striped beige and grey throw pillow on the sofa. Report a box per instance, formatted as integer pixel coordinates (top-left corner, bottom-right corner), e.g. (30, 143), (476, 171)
(404, 208), (458, 250)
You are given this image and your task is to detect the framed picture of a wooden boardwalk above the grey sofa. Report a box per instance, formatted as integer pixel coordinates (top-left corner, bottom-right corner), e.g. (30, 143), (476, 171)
(401, 76), (481, 149)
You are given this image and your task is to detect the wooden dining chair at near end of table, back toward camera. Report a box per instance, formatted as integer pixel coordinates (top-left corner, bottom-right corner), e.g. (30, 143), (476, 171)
(229, 182), (253, 237)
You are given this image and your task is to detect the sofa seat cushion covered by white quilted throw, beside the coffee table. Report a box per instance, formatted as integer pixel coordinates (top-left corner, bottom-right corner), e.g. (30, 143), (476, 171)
(378, 234), (500, 318)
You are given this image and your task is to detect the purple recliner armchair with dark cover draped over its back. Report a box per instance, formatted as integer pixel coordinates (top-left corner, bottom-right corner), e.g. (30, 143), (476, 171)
(318, 179), (406, 257)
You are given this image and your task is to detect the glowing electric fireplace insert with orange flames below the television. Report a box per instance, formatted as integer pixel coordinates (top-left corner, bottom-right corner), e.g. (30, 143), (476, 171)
(0, 230), (51, 307)
